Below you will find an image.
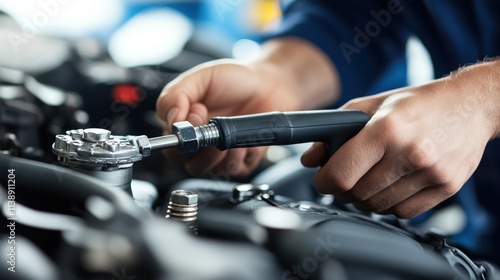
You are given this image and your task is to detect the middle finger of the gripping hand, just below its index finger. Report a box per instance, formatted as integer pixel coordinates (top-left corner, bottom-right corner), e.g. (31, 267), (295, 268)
(340, 151), (415, 202)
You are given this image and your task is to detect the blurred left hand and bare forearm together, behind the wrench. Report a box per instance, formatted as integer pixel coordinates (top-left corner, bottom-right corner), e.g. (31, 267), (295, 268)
(157, 39), (336, 176)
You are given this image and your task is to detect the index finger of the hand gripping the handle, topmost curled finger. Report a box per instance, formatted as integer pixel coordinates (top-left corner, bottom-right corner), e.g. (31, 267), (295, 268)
(315, 127), (385, 195)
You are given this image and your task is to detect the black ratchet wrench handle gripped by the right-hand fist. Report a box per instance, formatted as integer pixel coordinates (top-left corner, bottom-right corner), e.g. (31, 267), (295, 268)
(210, 110), (371, 155)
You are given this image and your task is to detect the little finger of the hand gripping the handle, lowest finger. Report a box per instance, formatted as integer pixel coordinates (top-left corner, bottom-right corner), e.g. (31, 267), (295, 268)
(386, 186), (455, 219)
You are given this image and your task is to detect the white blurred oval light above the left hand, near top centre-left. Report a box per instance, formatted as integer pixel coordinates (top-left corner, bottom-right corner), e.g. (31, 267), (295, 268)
(108, 9), (193, 67)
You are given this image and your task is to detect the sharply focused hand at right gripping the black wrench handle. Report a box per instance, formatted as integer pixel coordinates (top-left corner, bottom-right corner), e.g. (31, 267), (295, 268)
(302, 61), (499, 218)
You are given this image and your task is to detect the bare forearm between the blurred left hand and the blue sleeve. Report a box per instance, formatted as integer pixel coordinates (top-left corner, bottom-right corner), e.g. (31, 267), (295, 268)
(250, 38), (340, 109)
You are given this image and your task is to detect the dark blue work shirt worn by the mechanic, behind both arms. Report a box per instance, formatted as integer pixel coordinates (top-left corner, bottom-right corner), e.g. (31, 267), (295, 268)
(272, 0), (500, 263)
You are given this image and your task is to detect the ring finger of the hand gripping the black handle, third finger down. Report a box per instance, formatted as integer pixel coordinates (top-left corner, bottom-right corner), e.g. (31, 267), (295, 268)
(353, 171), (428, 213)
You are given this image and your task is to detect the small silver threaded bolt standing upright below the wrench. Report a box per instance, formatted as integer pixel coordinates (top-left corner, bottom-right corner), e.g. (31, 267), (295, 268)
(165, 190), (198, 223)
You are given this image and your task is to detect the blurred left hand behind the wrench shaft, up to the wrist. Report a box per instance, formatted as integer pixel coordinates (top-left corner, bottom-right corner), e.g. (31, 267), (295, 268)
(157, 60), (299, 175)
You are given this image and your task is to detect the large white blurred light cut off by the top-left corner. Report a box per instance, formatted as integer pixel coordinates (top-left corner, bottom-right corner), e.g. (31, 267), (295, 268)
(0, 0), (124, 37)
